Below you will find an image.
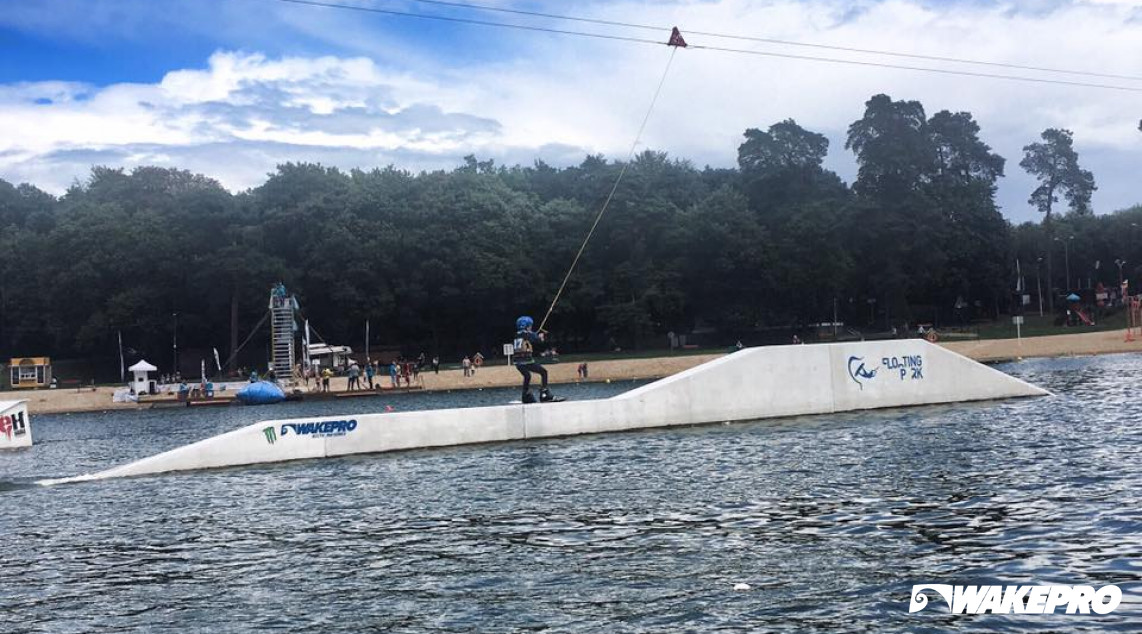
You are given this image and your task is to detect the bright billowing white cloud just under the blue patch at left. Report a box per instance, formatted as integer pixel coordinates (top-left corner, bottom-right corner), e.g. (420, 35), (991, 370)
(0, 53), (499, 185)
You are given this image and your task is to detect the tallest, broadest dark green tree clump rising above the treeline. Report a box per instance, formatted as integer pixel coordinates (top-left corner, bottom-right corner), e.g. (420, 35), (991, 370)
(846, 95), (1008, 322)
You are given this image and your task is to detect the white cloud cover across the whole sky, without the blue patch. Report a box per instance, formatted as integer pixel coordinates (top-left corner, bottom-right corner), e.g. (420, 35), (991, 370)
(0, 0), (1142, 218)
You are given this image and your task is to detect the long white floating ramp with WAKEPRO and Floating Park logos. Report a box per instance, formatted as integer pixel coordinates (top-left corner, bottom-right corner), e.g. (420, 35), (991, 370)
(42, 339), (1048, 484)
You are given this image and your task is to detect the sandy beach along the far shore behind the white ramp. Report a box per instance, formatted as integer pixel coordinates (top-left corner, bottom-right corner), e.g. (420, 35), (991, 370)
(11, 330), (1142, 416)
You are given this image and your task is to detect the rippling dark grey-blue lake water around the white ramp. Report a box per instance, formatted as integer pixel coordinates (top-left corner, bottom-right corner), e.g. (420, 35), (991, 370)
(0, 355), (1142, 633)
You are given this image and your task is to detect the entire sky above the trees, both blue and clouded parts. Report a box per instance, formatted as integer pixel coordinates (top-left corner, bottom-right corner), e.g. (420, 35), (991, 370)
(0, 0), (1142, 222)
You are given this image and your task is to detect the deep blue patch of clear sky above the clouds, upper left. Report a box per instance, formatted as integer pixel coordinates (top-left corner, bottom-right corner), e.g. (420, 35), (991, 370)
(0, 0), (548, 86)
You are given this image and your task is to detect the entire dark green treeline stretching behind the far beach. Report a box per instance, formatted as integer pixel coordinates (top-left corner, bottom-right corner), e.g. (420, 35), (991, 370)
(0, 90), (1142, 363)
